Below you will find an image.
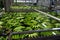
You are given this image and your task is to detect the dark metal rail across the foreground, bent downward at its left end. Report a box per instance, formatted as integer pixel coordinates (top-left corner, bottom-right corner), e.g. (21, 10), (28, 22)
(8, 28), (60, 40)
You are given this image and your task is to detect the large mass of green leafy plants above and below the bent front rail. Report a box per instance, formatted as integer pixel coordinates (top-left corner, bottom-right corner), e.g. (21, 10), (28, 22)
(0, 12), (60, 39)
